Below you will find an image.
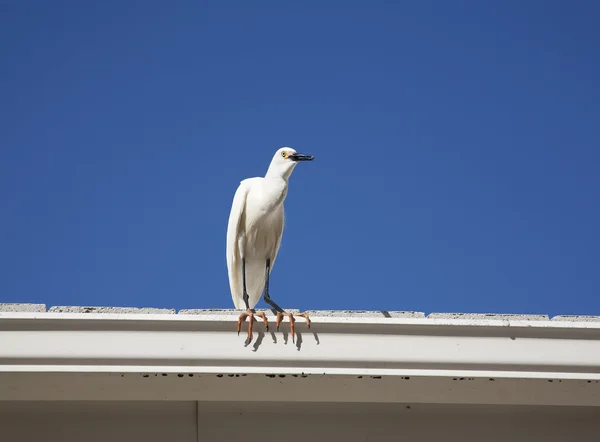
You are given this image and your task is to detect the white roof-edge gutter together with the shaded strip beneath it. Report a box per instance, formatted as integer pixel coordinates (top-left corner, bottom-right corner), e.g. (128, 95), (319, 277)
(0, 312), (600, 406)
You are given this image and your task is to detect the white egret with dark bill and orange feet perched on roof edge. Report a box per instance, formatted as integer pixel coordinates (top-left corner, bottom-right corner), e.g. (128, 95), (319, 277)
(226, 147), (314, 343)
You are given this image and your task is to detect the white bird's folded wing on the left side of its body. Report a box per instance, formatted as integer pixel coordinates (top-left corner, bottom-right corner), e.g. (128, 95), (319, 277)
(227, 178), (257, 309)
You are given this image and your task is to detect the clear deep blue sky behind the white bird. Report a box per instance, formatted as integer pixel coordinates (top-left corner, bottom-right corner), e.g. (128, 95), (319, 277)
(0, 0), (600, 315)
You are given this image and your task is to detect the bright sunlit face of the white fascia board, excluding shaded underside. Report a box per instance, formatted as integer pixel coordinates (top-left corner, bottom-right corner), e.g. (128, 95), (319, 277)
(0, 313), (600, 380)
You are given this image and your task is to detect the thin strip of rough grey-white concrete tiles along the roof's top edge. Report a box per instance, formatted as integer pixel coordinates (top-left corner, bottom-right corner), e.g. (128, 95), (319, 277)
(0, 303), (600, 322)
